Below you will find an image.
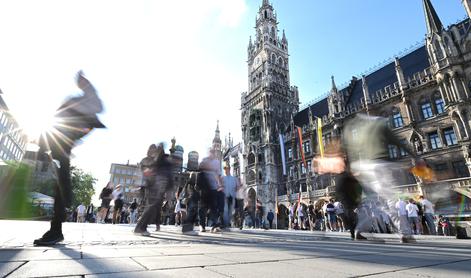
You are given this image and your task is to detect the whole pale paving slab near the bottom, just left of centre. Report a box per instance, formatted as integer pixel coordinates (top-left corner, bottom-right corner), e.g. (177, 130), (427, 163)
(133, 255), (232, 270)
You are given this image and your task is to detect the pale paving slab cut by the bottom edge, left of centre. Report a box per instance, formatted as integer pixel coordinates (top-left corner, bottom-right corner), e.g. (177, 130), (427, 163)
(85, 267), (227, 278)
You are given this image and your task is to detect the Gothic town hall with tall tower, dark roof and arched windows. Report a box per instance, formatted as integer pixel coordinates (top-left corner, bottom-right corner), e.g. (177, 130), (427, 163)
(242, 0), (471, 225)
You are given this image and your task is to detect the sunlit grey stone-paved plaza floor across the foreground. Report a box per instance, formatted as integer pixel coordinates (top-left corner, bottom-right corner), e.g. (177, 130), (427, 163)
(0, 220), (471, 277)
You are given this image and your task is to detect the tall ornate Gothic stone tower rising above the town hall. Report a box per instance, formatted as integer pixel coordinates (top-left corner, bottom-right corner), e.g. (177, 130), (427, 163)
(241, 0), (299, 212)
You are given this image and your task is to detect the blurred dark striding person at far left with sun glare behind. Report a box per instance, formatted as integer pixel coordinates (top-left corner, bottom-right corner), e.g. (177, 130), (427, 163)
(34, 71), (105, 246)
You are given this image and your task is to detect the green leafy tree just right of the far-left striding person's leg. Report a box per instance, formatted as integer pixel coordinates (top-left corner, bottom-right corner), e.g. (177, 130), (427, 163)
(70, 166), (97, 208)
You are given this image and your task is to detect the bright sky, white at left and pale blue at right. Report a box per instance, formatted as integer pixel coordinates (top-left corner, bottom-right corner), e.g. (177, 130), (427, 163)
(0, 0), (465, 202)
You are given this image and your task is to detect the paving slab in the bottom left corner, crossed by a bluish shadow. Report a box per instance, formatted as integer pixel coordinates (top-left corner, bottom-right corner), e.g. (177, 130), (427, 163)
(8, 258), (145, 278)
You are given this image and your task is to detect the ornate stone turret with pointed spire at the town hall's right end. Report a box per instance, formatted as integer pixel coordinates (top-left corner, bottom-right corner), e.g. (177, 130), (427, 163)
(423, 0), (471, 174)
